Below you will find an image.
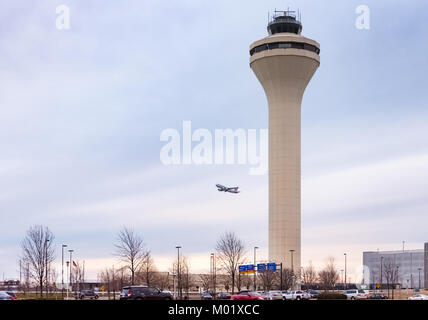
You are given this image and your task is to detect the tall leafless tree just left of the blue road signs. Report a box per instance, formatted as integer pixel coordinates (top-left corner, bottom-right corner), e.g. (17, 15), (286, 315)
(216, 232), (245, 294)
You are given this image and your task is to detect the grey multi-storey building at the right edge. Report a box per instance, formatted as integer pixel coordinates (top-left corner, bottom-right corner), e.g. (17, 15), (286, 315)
(363, 242), (428, 289)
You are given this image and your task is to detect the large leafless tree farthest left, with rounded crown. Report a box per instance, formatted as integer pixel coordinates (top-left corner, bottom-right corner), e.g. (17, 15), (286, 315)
(21, 225), (55, 297)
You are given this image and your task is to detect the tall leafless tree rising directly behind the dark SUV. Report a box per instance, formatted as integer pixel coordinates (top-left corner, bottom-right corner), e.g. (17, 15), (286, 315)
(115, 227), (148, 285)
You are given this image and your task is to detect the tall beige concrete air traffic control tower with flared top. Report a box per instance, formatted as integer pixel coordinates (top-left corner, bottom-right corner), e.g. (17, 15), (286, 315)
(250, 11), (320, 273)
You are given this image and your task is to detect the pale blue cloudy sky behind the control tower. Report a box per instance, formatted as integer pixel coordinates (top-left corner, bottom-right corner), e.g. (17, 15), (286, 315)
(0, 0), (428, 278)
